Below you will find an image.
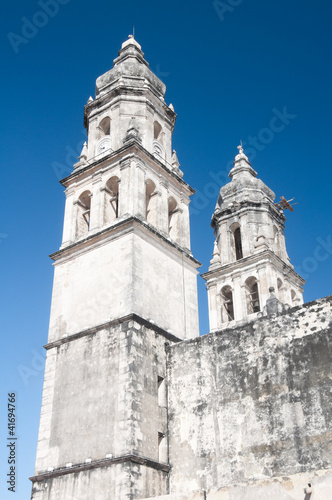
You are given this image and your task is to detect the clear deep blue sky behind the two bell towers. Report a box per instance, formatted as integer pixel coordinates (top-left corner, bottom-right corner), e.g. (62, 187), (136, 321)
(0, 0), (332, 500)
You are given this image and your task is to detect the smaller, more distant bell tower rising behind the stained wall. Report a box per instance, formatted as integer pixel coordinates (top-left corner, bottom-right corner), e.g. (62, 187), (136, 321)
(203, 146), (305, 331)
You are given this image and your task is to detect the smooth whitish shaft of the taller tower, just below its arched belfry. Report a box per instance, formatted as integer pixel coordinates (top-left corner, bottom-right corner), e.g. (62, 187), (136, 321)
(49, 221), (199, 342)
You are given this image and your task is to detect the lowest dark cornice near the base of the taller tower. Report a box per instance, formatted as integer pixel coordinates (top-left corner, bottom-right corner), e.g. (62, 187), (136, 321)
(29, 454), (170, 483)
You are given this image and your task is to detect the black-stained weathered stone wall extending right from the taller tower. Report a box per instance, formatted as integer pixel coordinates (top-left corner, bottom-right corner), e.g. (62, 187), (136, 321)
(168, 297), (332, 500)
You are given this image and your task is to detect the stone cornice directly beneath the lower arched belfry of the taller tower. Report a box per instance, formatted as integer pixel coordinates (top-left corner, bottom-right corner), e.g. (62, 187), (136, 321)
(50, 216), (202, 268)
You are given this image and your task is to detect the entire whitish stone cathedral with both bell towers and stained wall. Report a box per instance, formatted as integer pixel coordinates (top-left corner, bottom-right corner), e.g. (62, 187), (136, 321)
(31, 37), (332, 500)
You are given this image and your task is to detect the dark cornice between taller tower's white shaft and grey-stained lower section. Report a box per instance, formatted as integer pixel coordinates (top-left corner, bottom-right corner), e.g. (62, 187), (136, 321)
(44, 313), (182, 351)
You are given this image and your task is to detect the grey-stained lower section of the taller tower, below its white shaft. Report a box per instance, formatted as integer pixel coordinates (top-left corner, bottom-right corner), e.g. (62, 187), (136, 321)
(32, 318), (172, 500)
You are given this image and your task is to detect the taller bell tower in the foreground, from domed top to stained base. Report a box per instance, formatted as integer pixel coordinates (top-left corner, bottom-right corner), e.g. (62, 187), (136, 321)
(31, 36), (200, 500)
